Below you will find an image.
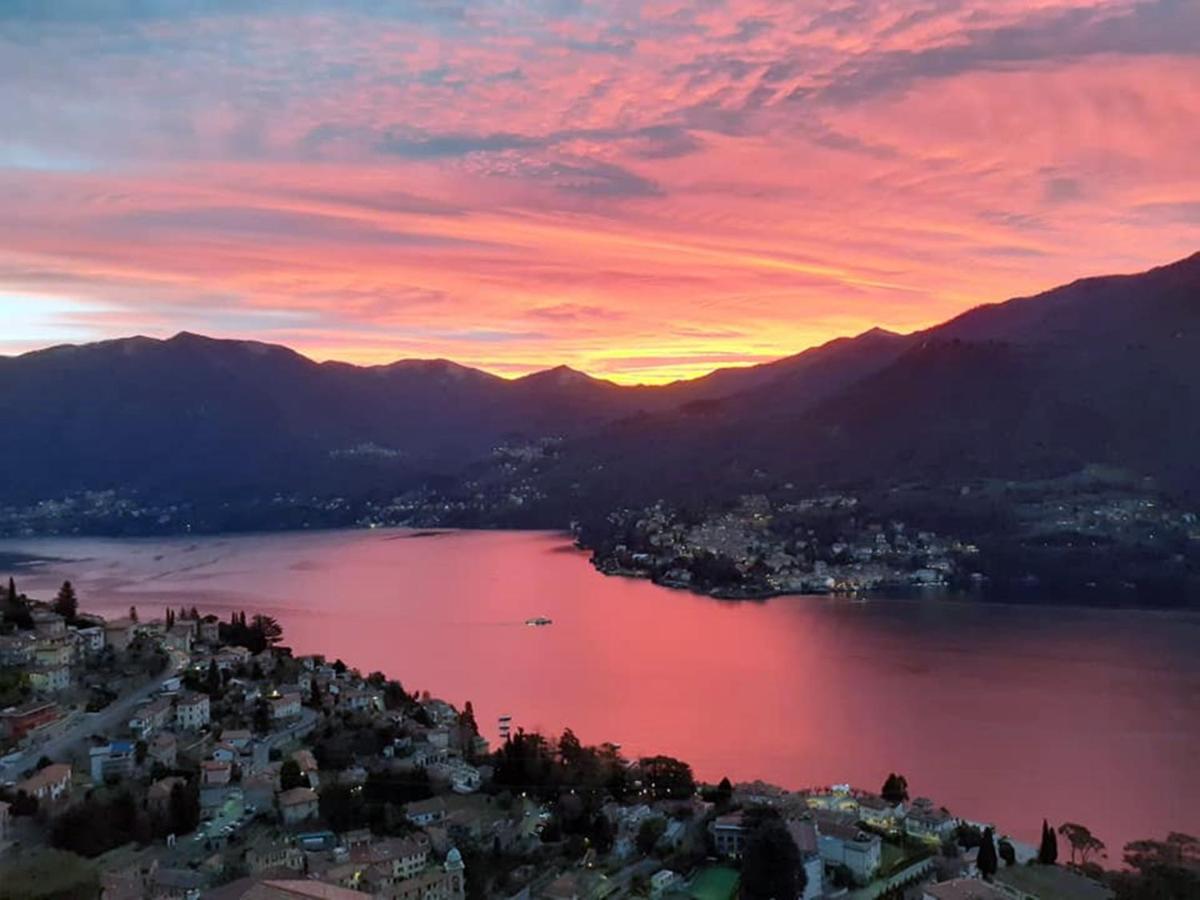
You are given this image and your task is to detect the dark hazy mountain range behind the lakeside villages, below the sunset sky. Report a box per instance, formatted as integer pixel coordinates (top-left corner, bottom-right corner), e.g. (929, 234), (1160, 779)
(0, 254), (1200, 535)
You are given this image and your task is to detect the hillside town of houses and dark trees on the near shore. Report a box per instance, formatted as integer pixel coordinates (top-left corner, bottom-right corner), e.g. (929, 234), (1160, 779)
(0, 578), (1200, 900)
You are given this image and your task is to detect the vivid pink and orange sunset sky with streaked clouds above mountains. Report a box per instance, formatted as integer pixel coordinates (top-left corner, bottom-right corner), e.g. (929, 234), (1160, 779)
(0, 0), (1200, 383)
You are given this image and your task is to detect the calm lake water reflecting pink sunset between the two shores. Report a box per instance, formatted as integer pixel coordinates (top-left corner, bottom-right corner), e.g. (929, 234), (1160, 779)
(0, 530), (1200, 863)
